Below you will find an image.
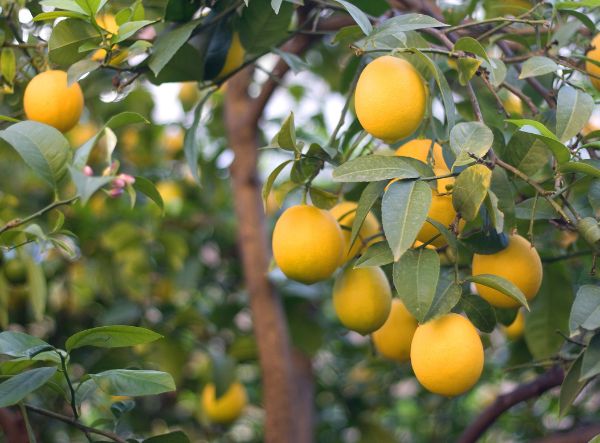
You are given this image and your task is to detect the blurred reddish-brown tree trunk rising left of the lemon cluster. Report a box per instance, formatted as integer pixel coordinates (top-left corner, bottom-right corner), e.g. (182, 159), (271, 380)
(225, 68), (300, 443)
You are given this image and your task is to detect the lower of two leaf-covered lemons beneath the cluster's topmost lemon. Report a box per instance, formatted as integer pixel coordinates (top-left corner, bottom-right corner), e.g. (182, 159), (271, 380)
(417, 169), (464, 248)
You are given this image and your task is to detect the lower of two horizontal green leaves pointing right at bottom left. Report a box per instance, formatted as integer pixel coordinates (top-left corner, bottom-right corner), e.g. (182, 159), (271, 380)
(90, 369), (175, 397)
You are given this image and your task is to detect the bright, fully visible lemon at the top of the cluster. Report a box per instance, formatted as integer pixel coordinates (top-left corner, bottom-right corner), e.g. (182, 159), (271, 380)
(354, 55), (427, 142)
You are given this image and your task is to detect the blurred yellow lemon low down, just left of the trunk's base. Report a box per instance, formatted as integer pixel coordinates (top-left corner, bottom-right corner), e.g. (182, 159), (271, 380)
(202, 382), (248, 424)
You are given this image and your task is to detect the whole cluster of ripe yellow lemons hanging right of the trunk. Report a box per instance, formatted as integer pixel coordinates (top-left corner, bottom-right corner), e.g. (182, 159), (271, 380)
(272, 56), (542, 396)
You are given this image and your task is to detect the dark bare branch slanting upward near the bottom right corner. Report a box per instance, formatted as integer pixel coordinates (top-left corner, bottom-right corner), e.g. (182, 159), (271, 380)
(458, 366), (564, 443)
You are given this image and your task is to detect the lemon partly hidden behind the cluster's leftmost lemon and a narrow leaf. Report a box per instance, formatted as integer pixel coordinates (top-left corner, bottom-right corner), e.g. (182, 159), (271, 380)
(329, 202), (381, 265)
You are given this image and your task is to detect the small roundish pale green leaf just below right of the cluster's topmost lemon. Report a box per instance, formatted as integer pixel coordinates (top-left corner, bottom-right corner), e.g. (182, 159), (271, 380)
(450, 122), (494, 168)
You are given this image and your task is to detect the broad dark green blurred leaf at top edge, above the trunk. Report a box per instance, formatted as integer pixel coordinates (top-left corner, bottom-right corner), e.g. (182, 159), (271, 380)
(238, 1), (294, 54)
